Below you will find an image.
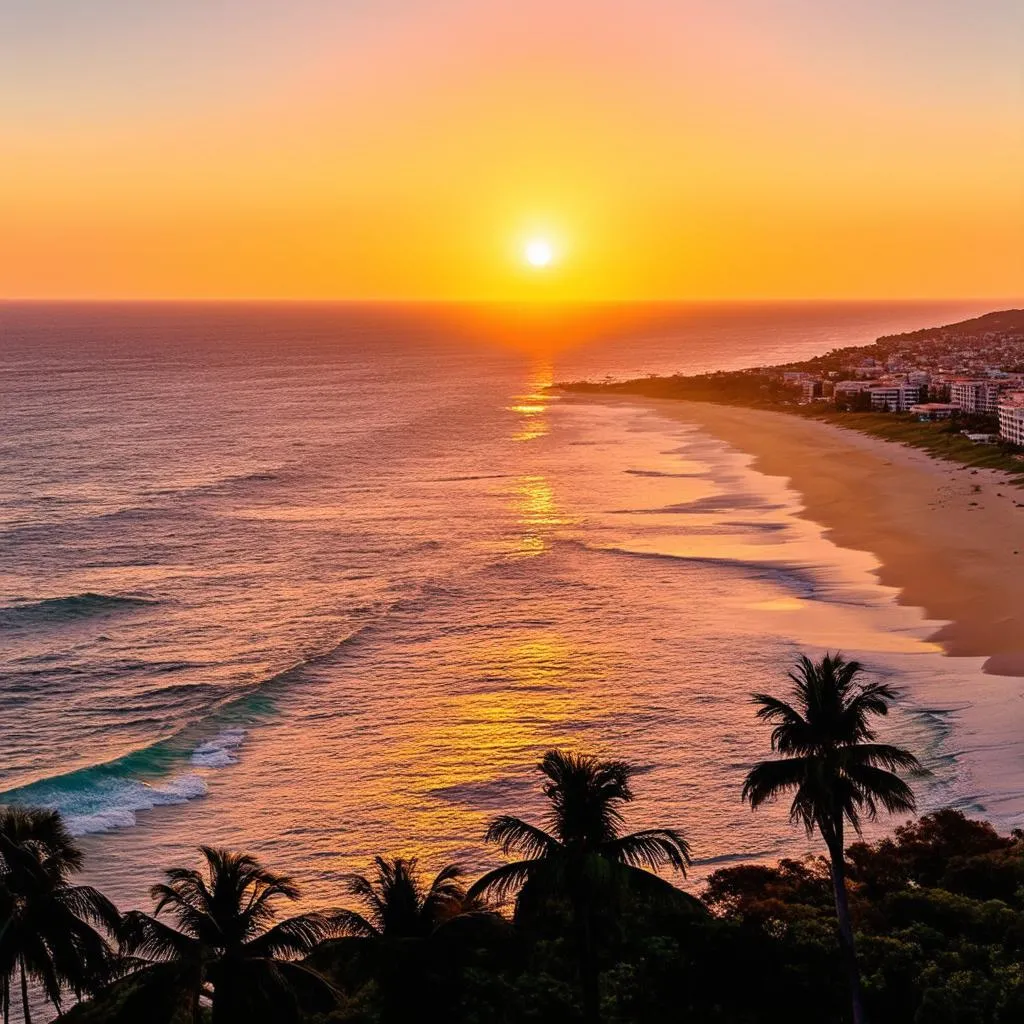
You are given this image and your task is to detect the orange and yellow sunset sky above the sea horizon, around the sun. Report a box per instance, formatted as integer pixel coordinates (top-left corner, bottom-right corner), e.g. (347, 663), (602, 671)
(0, 0), (1024, 300)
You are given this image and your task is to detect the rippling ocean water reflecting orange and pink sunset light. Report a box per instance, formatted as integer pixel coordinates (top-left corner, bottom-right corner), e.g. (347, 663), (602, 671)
(0, 303), (1017, 906)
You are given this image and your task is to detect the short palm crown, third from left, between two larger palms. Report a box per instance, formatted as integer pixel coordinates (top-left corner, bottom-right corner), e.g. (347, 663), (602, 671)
(338, 857), (484, 939)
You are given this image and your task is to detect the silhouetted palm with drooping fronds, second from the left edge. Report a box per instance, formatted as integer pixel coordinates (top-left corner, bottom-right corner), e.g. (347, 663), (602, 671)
(120, 846), (339, 1024)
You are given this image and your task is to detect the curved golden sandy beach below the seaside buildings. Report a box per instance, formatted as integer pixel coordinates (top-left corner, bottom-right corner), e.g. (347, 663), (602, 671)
(635, 399), (1024, 676)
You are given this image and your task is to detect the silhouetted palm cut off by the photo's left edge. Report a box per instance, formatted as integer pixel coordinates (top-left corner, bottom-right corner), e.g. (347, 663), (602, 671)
(0, 807), (120, 1024)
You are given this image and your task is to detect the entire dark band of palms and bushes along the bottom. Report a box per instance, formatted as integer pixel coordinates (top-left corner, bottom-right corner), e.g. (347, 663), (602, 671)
(6, 656), (1024, 1024)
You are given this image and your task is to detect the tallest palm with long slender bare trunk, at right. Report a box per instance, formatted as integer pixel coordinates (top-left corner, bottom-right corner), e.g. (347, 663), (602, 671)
(743, 653), (923, 1024)
